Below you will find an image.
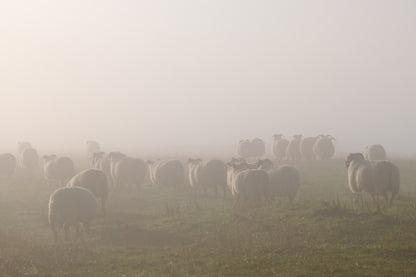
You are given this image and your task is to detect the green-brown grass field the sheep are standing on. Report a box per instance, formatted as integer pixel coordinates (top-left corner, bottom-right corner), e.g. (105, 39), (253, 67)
(0, 157), (416, 277)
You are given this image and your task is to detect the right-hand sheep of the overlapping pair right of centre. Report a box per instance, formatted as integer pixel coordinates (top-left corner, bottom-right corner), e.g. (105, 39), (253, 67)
(257, 159), (300, 202)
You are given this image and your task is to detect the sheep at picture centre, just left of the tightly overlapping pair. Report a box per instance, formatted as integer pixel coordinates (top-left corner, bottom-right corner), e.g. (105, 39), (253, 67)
(188, 159), (227, 198)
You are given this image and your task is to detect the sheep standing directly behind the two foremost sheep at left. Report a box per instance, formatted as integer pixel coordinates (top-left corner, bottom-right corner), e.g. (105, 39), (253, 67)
(43, 155), (75, 184)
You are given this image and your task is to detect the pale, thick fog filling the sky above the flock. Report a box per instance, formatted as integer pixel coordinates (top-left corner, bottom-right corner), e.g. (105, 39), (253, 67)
(0, 0), (416, 156)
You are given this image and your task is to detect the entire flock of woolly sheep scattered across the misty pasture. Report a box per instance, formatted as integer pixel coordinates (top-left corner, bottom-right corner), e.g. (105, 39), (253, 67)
(0, 138), (400, 240)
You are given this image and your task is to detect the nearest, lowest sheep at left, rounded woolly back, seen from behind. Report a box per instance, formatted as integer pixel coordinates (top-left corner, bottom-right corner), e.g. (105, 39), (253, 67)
(49, 187), (97, 242)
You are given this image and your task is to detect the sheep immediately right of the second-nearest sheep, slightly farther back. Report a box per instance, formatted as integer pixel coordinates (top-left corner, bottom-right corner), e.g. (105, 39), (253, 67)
(112, 157), (146, 188)
